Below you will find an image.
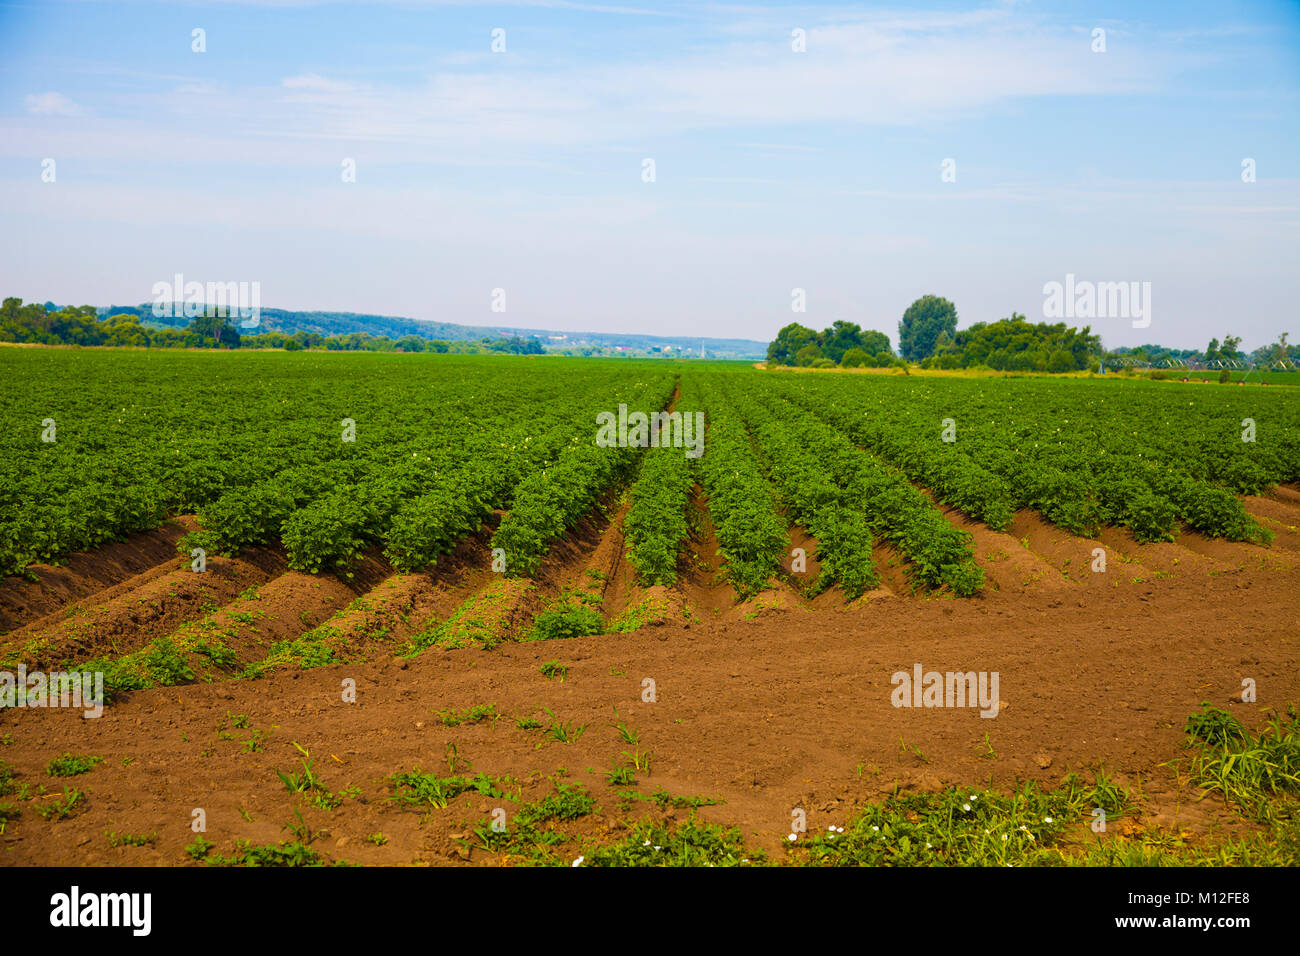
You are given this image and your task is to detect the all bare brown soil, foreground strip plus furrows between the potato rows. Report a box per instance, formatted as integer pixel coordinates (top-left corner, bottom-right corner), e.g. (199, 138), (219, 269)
(0, 488), (1300, 865)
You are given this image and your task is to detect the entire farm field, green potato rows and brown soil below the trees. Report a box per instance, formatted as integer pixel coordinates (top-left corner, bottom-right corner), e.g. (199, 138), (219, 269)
(0, 349), (1300, 865)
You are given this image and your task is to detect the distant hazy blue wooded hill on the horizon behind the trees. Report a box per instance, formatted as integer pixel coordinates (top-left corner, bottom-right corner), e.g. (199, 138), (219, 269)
(99, 303), (767, 359)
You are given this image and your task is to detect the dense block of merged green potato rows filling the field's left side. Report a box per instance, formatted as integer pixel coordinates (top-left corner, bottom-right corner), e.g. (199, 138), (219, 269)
(0, 350), (670, 574)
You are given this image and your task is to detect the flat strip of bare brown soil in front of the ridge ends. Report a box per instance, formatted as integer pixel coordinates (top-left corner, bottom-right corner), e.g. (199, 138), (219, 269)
(0, 561), (1300, 864)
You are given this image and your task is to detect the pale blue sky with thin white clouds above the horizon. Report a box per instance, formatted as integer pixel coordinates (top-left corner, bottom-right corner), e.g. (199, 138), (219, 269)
(0, 0), (1300, 350)
